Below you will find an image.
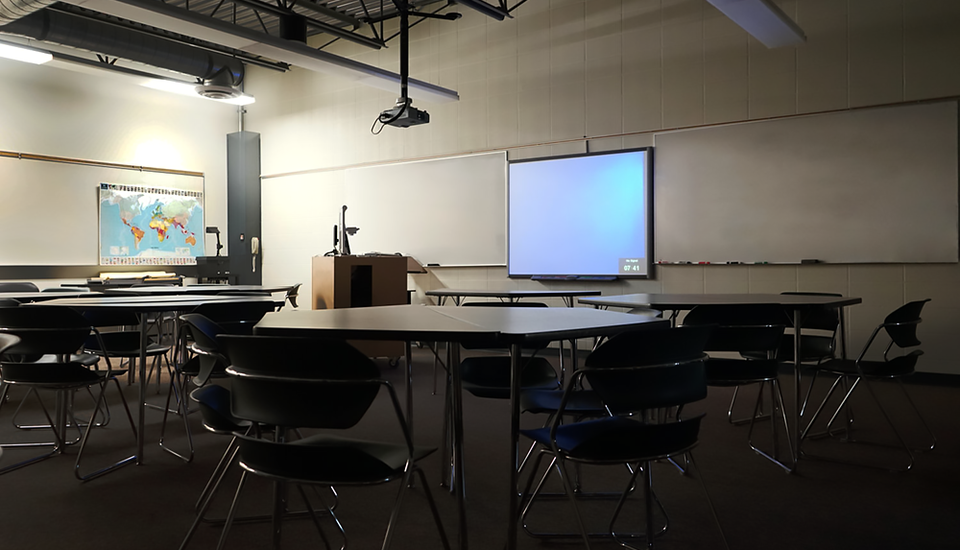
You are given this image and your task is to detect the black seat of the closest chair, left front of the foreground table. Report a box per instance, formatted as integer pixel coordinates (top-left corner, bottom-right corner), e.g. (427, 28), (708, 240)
(240, 434), (436, 485)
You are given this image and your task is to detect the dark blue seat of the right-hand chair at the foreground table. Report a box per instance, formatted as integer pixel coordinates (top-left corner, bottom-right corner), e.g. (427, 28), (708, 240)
(520, 415), (703, 463)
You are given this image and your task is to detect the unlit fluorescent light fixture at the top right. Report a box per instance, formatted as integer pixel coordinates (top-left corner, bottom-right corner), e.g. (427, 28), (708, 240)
(707, 0), (807, 48)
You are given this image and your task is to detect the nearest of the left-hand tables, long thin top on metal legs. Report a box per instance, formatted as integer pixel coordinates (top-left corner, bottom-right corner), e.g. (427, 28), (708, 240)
(24, 294), (283, 464)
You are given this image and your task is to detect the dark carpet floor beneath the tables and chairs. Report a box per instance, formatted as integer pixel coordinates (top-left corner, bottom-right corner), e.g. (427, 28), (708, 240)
(0, 350), (960, 550)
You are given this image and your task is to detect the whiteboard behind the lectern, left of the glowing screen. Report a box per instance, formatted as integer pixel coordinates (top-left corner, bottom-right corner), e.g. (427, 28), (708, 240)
(261, 151), (507, 266)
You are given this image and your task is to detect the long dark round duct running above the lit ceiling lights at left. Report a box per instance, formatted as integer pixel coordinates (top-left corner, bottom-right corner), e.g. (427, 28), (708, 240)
(0, 7), (243, 87)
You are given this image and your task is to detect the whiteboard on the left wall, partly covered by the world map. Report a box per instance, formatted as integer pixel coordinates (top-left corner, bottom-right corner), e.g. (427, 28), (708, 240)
(0, 157), (203, 266)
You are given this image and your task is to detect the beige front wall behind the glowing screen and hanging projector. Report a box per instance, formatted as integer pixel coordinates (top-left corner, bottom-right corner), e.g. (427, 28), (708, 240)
(247, 0), (960, 374)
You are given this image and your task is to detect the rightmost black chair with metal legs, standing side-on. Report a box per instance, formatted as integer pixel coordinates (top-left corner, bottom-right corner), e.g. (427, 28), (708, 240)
(801, 299), (937, 471)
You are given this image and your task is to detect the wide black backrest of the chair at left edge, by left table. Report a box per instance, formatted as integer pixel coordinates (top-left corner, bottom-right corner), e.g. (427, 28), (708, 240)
(0, 306), (90, 360)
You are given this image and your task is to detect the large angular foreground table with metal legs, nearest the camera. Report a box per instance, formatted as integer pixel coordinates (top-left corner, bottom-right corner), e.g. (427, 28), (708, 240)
(254, 305), (667, 550)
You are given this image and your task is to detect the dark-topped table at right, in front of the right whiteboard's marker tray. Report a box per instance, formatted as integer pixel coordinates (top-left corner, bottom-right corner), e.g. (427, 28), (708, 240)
(579, 294), (863, 470)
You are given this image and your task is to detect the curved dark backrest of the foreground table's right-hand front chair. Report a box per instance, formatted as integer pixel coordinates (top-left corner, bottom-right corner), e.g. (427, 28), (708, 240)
(582, 325), (713, 412)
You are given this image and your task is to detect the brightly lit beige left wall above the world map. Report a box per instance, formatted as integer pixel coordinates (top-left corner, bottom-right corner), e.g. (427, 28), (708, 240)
(0, 55), (238, 258)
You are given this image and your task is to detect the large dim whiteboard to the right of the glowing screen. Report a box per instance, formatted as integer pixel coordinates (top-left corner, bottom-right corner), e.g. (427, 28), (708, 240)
(654, 102), (958, 263)
